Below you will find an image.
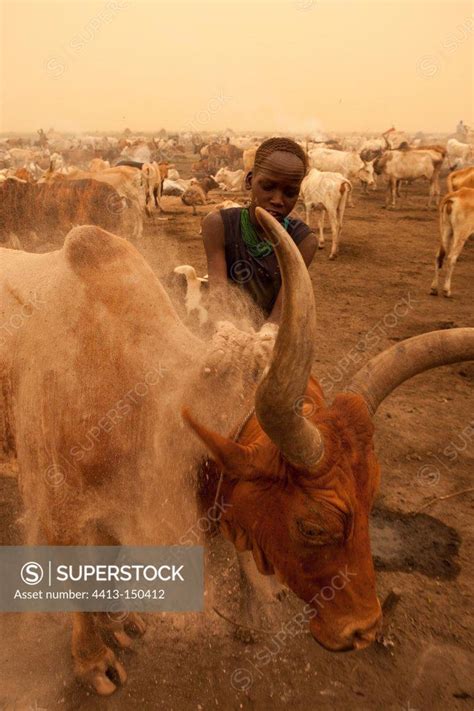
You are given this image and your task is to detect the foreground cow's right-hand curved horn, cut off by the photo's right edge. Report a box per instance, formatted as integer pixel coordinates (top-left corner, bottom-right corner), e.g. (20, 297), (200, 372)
(345, 328), (474, 415)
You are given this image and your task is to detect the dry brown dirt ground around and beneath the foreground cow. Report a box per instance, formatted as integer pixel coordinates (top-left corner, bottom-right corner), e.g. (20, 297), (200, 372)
(0, 163), (474, 711)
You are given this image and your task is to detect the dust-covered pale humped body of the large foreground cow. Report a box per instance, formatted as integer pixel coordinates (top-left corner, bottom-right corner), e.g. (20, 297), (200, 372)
(0, 227), (276, 556)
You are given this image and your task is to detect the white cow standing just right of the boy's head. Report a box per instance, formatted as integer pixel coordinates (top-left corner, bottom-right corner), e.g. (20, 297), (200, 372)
(300, 168), (352, 259)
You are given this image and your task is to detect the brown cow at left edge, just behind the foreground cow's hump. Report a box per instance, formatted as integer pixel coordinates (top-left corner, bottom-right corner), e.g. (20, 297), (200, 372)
(0, 179), (127, 248)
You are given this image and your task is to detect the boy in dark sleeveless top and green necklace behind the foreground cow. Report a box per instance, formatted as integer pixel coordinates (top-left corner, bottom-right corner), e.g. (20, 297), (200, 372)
(202, 138), (316, 323)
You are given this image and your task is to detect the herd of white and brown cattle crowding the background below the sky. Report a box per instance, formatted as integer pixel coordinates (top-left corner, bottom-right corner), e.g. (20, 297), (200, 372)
(0, 129), (474, 296)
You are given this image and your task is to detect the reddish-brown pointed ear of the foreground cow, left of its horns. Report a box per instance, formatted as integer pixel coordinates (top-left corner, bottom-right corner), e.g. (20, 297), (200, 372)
(181, 408), (255, 479)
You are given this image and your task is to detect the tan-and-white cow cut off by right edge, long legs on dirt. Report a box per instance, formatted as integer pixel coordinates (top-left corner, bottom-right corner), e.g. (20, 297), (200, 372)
(431, 188), (474, 297)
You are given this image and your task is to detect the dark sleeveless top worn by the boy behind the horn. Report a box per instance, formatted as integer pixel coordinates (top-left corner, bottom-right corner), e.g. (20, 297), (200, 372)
(220, 207), (312, 316)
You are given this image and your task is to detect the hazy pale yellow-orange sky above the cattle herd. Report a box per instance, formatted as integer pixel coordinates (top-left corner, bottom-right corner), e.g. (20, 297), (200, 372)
(0, 0), (474, 132)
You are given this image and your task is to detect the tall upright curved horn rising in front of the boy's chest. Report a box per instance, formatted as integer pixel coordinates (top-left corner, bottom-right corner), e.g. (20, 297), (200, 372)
(255, 207), (324, 468)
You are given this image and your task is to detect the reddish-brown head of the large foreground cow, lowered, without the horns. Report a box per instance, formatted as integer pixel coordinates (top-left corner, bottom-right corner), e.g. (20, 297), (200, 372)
(184, 378), (380, 648)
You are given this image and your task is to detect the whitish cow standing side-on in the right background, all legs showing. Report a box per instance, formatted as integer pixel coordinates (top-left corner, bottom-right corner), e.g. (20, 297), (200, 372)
(375, 148), (444, 207)
